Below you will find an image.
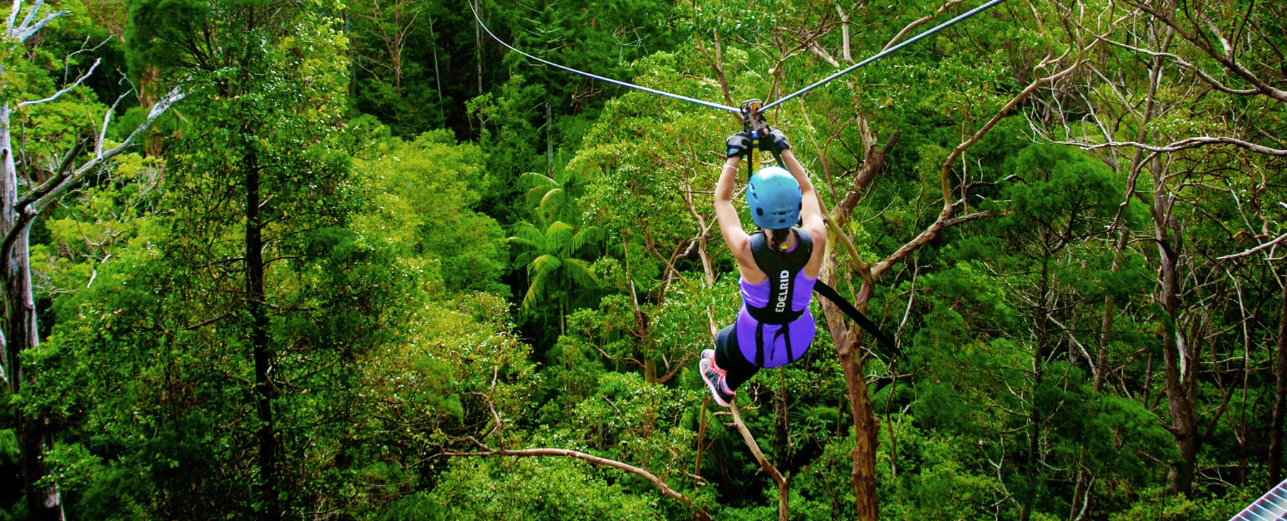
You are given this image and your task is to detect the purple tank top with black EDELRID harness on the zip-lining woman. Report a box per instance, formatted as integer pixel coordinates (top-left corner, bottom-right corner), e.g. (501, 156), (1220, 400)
(736, 228), (817, 368)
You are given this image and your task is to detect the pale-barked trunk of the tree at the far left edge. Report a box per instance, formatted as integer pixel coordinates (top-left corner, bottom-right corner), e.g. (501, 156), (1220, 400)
(0, 104), (62, 520)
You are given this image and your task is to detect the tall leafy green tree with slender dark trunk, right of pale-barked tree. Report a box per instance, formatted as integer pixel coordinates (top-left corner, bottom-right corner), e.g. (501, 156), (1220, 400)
(118, 1), (383, 518)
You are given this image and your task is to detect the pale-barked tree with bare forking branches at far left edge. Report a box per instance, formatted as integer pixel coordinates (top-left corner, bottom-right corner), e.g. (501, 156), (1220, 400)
(0, 0), (181, 518)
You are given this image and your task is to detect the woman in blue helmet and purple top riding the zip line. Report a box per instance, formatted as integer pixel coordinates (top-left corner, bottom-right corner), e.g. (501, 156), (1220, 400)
(699, 130), (826, 407)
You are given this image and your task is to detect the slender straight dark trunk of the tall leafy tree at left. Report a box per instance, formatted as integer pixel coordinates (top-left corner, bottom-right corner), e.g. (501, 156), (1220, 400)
(246, 147), (282, 521)
